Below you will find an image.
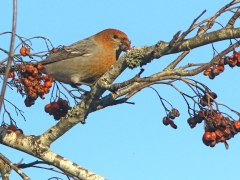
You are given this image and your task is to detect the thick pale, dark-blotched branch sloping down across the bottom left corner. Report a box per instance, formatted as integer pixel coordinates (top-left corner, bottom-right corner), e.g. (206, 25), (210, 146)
(2, 132), (105, 180)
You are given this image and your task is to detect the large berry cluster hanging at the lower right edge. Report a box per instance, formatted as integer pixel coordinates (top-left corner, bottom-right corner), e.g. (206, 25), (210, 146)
(187, 110), (240, 147)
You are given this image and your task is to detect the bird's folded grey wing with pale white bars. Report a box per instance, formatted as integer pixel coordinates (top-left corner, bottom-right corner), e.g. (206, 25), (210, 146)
(41, 37), (97, 65)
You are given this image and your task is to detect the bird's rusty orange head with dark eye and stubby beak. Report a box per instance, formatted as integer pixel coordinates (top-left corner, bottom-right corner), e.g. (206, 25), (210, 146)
(93, 29), (131, 54)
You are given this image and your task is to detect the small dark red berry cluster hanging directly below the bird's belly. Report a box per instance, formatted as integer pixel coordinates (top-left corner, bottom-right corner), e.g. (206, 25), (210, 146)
(44, 98), (71, 120)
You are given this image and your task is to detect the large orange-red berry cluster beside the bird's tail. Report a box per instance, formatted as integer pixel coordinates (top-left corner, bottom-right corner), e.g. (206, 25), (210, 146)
(13, 63), (54, 107)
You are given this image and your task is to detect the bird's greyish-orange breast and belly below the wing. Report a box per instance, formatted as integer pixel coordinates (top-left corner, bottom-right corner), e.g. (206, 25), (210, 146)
(45, 52), (116, 84)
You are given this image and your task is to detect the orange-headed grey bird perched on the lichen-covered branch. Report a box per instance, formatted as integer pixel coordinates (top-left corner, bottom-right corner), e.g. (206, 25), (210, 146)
(41, 29), (131, 86)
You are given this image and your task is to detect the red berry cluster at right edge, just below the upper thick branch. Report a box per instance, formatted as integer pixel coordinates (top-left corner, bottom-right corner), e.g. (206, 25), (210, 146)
(203, 51), (240, 79)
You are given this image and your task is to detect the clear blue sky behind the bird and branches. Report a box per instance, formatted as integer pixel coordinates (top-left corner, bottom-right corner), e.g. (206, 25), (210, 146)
(0, 0), (240, 180)
